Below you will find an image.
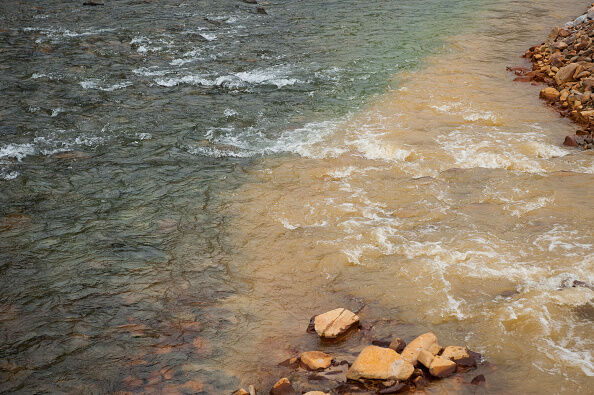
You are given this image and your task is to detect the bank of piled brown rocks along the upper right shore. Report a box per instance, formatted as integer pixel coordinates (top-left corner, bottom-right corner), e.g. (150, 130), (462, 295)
(508, 3), (594, 149)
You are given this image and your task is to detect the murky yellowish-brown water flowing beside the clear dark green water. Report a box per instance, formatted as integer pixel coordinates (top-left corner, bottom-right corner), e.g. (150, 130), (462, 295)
(224, 1), (594, 393)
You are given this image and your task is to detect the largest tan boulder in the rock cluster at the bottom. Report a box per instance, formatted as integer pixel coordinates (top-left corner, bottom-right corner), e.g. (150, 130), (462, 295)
(347, 346), (415, 381)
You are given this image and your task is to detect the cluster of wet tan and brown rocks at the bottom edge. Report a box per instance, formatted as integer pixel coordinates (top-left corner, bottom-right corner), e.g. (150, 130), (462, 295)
(233, 308), (486, 395)
